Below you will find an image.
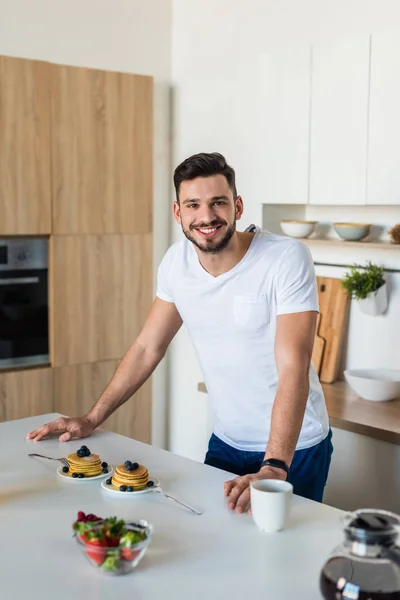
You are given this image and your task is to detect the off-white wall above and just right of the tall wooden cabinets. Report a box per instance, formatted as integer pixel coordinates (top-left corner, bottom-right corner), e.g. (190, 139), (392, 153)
(0, 0), (172, 446)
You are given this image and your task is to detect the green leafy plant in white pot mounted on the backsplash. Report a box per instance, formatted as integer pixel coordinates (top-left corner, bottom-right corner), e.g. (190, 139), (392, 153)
(342, 262), (388, 316)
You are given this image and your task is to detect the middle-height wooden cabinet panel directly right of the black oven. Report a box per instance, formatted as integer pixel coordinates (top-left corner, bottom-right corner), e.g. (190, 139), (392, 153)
(50, 234), (152, 366)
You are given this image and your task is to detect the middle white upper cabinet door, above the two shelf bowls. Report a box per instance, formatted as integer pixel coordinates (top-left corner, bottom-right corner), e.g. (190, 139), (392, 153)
(309, 36), (370, 205)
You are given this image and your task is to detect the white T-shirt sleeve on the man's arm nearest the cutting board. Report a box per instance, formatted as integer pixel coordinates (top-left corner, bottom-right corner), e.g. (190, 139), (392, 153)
(276, 241), (319, 315)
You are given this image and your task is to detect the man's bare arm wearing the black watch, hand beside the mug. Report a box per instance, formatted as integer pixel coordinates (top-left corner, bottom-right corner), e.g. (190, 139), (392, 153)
(224, 311), (317, 513)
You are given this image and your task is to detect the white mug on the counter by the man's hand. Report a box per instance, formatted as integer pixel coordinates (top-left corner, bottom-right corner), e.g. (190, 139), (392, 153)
(250, 479), (293, 533)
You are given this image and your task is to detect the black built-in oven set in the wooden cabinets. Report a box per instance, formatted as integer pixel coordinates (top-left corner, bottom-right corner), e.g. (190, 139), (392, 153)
(0, 237), (49, 369)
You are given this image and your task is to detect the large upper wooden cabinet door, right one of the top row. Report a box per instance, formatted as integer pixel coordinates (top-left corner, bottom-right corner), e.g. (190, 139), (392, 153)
(51, 65), (153, 234)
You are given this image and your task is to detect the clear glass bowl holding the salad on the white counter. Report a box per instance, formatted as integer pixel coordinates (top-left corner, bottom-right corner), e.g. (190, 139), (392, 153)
(75, 520), (153, 575)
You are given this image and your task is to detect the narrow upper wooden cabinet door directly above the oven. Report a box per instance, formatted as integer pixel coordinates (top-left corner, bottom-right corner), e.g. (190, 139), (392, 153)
(0, 56), (51, 235)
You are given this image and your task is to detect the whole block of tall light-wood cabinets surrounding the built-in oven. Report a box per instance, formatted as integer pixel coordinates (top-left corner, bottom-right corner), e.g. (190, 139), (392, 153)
(0, 57), (153, 442)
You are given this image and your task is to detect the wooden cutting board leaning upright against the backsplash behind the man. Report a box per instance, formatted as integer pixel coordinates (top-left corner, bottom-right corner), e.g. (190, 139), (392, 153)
(313, 277), (350, 383)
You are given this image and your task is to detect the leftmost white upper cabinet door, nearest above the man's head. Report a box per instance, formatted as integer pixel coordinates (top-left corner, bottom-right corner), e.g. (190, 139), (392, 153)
(253, 45), (311, 204)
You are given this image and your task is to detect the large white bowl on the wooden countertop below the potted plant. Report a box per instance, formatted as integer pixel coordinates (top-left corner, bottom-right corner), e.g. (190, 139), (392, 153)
(344, 369), (400, 402)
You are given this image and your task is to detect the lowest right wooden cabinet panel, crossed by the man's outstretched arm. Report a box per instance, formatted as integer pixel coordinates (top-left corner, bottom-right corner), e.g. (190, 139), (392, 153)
(54, 361), (151, 443)
